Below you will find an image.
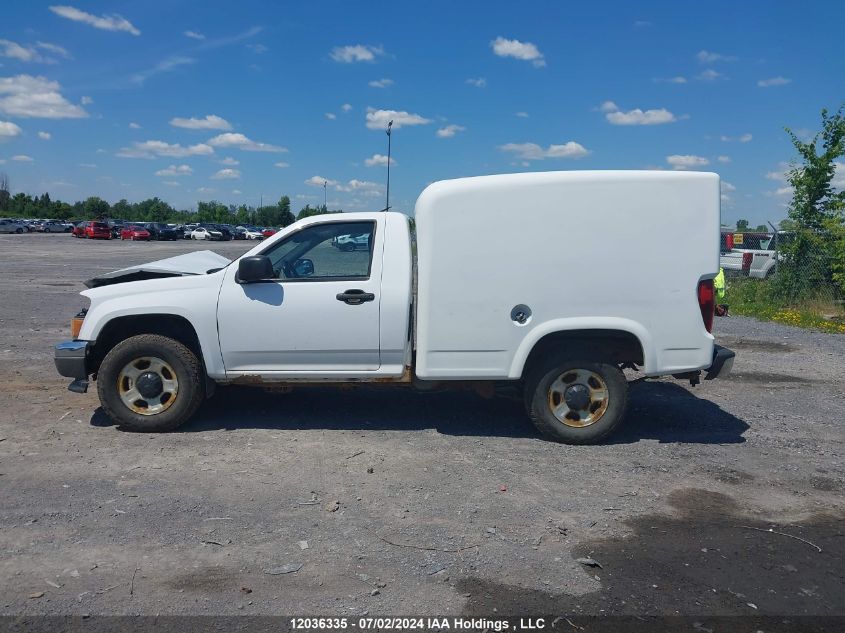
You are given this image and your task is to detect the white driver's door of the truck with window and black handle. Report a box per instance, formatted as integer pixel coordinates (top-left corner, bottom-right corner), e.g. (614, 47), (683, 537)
(217, 220), (384, 376)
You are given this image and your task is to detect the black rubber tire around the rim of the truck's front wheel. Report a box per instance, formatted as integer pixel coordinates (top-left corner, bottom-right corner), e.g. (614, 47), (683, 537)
(97, 334), (205, 433)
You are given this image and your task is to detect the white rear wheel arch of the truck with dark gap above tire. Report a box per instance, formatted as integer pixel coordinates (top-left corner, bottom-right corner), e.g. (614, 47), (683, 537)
(509, 319), (655, 379)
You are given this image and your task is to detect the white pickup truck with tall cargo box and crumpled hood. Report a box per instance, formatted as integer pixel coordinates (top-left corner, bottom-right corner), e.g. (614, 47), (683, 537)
(55, 171), (734, 444)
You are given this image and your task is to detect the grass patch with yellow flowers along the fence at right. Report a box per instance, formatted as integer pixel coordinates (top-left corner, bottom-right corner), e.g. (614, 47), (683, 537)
(722, 277), (845, 334)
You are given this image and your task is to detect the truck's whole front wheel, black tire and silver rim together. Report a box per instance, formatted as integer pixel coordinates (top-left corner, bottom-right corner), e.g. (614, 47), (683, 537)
(97, 334), (205, 433)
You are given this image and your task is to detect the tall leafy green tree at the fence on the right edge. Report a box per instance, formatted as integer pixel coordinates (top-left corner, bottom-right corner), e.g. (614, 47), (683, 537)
(777, 104), (845, 301)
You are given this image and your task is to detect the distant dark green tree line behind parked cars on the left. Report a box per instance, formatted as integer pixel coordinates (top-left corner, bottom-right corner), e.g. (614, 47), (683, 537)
(0, 179), (342, 227)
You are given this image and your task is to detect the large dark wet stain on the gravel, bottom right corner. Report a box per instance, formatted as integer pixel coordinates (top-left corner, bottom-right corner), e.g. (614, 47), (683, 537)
(458, 489), (845, 616)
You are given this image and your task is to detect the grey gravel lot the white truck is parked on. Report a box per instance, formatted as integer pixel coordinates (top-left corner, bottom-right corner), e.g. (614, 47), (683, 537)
(0, 234), (845, 616)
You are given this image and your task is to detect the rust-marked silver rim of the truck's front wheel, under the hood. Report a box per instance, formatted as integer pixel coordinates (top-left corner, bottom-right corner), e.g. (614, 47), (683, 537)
(117, 356), (179, 415)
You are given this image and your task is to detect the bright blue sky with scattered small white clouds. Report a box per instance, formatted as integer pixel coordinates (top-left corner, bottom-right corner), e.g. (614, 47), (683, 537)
(0, 0), (845, 225)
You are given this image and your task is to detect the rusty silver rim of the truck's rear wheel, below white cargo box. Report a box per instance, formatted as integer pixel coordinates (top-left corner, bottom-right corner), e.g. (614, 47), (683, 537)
(548, 369), (610, 428)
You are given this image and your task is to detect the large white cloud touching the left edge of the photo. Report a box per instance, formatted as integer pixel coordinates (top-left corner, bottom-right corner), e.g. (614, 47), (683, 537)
(0, 75), (88, 119)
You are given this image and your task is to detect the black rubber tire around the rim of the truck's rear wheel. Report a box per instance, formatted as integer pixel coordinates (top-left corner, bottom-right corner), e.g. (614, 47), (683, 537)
(525, 356), (628, 444)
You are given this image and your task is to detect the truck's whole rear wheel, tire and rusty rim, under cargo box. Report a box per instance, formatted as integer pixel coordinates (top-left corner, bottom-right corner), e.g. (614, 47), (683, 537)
(525, 358), (628, 444)
